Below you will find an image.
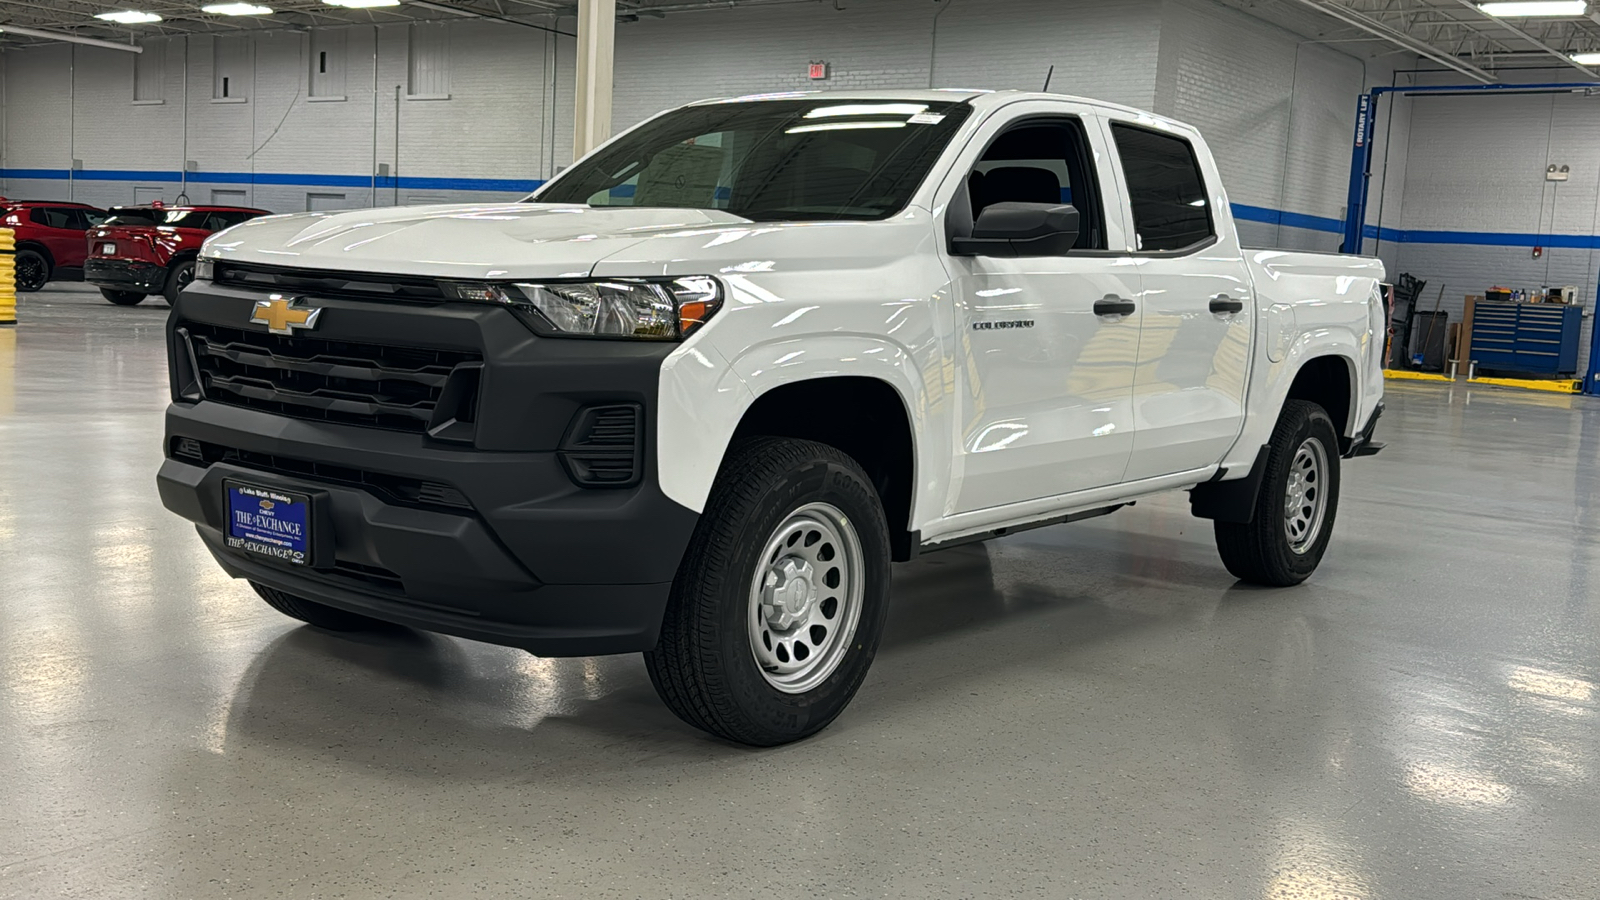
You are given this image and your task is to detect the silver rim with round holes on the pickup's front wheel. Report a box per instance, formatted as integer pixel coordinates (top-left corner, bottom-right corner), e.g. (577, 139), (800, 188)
(746, 503), (866, 693)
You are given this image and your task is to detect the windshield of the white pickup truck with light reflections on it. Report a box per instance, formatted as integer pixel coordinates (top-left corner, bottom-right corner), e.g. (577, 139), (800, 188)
(531, 98), (971, 221)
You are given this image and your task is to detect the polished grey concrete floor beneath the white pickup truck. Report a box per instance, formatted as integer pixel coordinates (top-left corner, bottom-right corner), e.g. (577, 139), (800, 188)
(0, 287), (1600, 900)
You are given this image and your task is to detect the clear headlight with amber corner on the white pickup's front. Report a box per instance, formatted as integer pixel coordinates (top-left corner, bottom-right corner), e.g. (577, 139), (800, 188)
(450, 275), (722, 341)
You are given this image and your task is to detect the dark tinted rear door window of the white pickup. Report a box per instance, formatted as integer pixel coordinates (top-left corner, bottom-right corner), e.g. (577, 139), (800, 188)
(1110, 123), (1216, 253)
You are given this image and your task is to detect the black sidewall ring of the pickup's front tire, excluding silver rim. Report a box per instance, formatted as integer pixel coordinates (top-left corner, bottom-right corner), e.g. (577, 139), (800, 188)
(717, 460), (890, 740)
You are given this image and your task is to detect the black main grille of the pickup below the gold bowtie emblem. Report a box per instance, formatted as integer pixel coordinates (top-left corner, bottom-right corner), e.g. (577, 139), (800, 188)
(178, 322), (480, 432)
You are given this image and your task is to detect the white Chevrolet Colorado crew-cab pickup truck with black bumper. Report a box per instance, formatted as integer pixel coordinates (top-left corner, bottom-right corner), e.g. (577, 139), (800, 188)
(158, 91), (1384, 745)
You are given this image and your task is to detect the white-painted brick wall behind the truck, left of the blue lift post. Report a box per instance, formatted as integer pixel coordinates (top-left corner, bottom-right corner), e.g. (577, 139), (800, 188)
(0, 0), (1362, 248)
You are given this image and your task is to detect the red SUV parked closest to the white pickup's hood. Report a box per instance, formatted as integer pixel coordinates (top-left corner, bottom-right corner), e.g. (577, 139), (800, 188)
(83, 203), (270, 306)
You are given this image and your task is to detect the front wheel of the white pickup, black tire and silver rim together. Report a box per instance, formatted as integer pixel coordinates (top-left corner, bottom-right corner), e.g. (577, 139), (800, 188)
(645, 437), (890, 746)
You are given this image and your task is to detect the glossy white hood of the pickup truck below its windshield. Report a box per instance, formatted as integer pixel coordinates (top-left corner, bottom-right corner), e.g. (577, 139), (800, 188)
(206, 203), (750, 279)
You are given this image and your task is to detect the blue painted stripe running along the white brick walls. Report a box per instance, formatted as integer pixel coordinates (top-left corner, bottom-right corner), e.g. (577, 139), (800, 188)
(0, 168), (1600, 250)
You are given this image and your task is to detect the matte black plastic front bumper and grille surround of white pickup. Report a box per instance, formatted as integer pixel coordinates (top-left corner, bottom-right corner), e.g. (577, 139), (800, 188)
(157, 283), (698, 657)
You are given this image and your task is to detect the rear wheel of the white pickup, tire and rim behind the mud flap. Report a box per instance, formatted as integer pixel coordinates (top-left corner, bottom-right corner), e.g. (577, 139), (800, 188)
(1214, 400), (1339, 588)
